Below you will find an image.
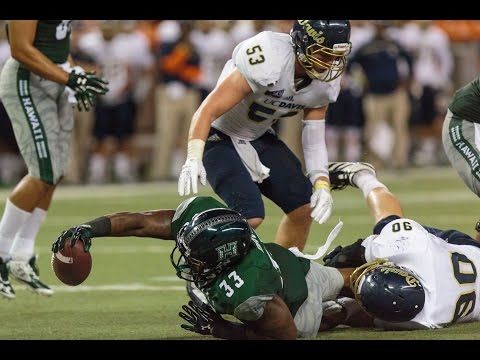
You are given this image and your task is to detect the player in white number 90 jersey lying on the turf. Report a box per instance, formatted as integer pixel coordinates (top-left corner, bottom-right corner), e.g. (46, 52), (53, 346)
(324, 163), (480, 330)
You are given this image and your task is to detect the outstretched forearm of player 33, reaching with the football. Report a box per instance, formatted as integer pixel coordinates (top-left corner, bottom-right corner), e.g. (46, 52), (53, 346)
(86, 210), (175, 240)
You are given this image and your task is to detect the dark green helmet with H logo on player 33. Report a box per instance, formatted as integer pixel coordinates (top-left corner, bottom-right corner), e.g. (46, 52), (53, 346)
(170, 208), (252, 288)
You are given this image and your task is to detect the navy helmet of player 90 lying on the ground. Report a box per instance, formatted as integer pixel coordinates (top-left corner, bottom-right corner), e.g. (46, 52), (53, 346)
(350, 259), (425, 322)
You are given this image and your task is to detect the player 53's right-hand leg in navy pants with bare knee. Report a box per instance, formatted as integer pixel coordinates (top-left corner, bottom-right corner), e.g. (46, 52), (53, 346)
(252, 133), (312, 250)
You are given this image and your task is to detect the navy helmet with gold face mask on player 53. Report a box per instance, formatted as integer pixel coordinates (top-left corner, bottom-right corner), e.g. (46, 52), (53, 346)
(290, 20), (352, 81)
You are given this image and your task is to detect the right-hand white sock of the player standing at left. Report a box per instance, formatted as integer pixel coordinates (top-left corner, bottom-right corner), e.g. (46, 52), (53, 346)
(10, 208), (47, 261)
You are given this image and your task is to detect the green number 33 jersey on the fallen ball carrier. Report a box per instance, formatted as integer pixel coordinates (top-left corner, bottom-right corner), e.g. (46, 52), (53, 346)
(172, 197), (310, 321)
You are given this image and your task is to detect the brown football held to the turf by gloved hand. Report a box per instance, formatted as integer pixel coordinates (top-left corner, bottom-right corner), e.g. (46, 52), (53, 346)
(52, 239), (92, 286)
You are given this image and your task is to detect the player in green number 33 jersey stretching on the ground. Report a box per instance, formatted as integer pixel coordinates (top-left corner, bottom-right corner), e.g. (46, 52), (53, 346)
(52, 197), (353, 339)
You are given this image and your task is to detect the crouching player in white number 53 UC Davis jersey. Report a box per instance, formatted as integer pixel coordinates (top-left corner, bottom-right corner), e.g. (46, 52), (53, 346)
(178, 20), (351, 249)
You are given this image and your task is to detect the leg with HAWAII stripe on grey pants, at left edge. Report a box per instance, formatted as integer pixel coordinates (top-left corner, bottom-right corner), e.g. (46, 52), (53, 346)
(0, 59), (56, 298)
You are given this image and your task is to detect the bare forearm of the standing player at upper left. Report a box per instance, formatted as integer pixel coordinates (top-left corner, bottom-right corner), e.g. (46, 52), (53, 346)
(12, 45), (69, 85)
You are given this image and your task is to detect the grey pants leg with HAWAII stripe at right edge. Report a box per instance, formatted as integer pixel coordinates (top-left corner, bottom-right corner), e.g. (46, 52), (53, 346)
(442, 110), (480, 241)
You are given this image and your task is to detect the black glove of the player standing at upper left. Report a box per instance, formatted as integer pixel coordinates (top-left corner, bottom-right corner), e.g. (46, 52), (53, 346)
(67, 70), (108, 111)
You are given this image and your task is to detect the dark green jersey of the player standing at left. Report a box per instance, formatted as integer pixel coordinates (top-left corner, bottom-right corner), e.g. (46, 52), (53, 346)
(6, 20), (72, 64)
